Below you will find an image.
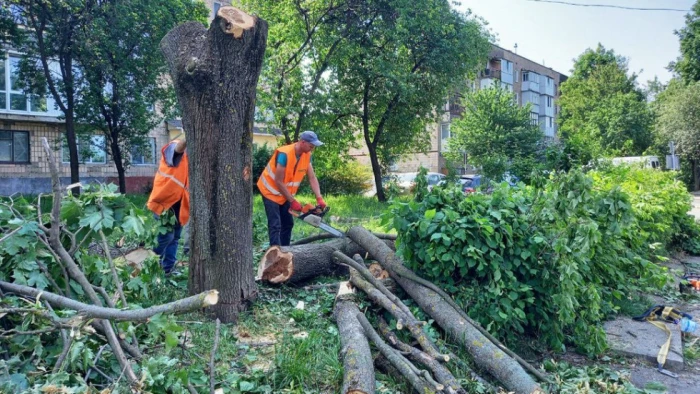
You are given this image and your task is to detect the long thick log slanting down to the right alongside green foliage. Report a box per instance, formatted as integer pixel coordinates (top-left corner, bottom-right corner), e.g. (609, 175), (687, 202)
(347, 227), (543, 394)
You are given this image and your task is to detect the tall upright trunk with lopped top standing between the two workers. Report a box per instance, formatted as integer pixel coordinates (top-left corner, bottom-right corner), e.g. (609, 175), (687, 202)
(161, 7), (267, 323)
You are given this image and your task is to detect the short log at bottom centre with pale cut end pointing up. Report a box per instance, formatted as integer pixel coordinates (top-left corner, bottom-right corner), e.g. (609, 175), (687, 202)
(333, 282), (375, 394)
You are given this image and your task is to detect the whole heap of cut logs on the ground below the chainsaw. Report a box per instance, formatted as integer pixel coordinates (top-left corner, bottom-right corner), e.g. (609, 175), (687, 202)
(258, 227), (547, 394)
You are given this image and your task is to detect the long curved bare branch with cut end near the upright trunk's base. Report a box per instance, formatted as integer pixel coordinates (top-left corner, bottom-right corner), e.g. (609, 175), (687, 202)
(0, 281), (219, 321)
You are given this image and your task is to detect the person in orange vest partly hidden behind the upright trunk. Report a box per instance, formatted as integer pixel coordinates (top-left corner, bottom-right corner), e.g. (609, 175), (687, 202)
(146, 139), (190, 275)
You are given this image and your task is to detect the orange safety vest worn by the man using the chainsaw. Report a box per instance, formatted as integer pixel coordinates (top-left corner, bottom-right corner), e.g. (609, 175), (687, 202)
(258, 144), (311, 205)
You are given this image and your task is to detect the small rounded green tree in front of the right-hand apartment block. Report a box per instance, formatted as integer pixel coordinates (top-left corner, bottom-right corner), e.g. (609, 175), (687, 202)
(448, 86), (544, 179)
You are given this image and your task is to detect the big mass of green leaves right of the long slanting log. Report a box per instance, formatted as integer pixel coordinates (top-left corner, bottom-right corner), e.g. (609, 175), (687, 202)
(388, 171), (666, 354)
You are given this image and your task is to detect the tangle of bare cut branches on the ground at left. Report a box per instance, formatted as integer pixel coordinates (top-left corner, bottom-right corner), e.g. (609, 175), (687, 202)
(0, 138), (219, 392)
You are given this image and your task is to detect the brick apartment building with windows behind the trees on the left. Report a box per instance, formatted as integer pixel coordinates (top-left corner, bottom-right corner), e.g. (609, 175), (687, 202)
(0, 0), (278, 196)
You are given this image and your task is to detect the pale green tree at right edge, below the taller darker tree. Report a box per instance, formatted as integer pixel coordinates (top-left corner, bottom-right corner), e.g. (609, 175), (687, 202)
(656, 79), (700, 190)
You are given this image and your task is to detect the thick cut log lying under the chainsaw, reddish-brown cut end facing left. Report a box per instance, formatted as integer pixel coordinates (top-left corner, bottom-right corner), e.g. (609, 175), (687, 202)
(257, 238), (393, 284)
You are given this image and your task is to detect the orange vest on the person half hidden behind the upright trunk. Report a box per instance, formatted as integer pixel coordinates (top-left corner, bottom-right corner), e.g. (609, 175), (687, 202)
(146, 140), (190, 226)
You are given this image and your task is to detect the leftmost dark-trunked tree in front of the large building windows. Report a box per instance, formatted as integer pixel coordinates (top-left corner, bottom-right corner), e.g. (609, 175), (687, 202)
(0, 0), (91, 193)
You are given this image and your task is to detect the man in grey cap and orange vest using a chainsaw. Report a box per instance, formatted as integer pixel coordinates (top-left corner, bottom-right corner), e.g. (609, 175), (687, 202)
(258, 131), (326, 246)
